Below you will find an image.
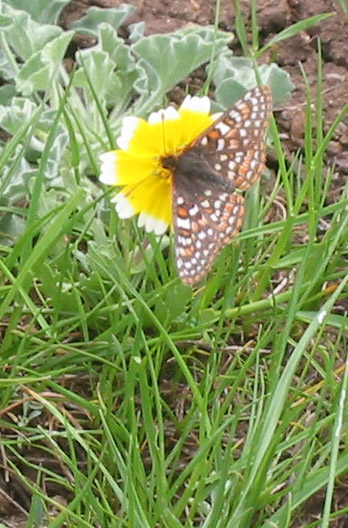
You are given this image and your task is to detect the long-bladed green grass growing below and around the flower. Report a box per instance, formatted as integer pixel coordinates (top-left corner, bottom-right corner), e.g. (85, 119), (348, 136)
(0, 1), (348, 528)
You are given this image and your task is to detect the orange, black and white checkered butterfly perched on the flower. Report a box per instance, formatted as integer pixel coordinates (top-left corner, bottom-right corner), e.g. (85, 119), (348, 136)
(161, 86), (272, 285)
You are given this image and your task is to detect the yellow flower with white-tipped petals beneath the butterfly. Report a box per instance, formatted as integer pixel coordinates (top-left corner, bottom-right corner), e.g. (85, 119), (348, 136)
(100, 95), (217, 235)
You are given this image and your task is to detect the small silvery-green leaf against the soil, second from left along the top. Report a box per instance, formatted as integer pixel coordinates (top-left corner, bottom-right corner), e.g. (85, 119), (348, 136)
(71, 4), (135, 36)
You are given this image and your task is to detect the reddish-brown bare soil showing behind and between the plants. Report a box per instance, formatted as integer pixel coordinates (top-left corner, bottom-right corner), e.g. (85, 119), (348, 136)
(0, 0), (348, 528)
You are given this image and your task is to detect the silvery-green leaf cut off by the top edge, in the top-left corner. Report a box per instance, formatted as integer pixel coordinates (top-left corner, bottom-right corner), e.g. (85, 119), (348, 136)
(4, 0), (70, 24)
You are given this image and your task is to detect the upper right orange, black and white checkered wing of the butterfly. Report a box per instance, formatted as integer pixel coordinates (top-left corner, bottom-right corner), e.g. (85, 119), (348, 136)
(194, 86), (272, 191)
